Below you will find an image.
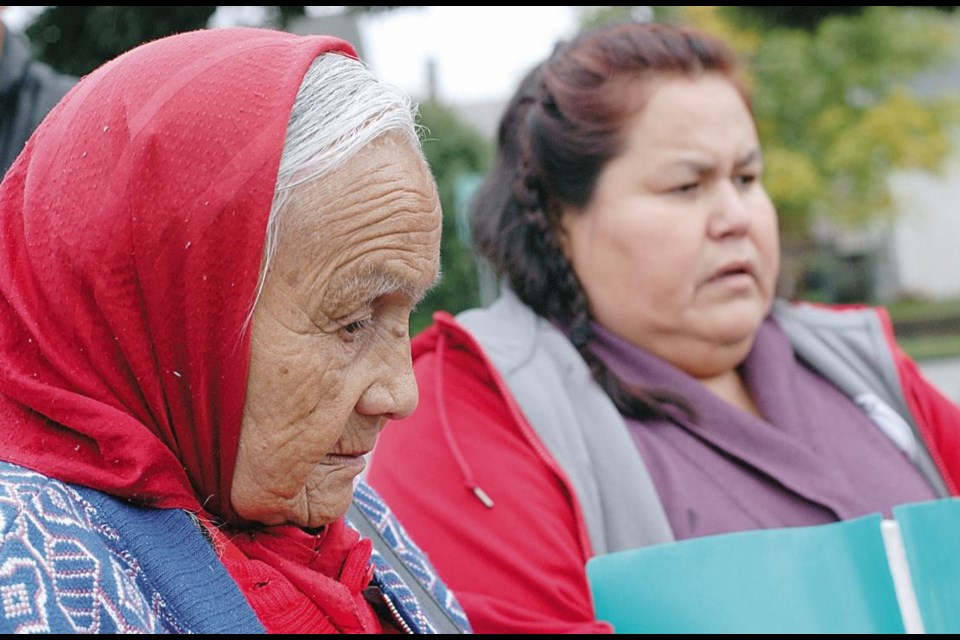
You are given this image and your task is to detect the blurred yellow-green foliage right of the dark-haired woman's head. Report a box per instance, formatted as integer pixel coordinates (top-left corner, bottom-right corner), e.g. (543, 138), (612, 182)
(750, 7), (960, 233)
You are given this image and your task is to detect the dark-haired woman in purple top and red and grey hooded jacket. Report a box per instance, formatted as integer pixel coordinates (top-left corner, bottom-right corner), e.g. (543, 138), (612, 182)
(369, 24), (960, 632)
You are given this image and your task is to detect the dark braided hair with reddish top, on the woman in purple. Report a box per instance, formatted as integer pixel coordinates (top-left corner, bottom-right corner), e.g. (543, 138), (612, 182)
(472, 22), (750, 420)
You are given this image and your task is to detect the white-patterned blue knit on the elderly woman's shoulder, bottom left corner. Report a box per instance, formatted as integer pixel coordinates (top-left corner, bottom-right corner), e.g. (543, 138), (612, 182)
(0, 465), (169, 633)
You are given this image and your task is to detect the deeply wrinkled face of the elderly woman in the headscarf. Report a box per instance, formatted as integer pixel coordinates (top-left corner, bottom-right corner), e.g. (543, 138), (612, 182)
(231, 135), (441, 527)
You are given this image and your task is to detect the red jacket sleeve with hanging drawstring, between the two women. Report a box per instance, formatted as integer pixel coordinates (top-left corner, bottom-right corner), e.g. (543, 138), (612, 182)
(367, 314), (612, 633)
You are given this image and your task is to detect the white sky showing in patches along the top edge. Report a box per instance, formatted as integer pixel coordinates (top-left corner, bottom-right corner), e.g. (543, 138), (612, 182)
(4, 6), (577, 104)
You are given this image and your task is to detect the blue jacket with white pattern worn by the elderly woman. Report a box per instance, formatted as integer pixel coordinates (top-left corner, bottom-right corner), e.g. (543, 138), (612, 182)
(0, 462), (469, 633)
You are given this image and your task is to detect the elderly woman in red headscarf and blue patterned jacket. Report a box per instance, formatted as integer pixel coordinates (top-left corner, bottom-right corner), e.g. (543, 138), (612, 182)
(0, 29), (463, 633)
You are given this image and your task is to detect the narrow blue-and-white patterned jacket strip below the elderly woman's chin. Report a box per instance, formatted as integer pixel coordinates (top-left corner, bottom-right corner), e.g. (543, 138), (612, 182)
(354, 482), (470, 633)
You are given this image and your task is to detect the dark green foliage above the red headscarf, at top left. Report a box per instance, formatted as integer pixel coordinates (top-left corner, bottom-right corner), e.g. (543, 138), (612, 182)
(27, 6), (216, 76)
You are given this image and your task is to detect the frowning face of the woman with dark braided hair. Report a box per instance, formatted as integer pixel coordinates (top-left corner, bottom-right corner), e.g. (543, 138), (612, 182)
(561, 75), (779, 378)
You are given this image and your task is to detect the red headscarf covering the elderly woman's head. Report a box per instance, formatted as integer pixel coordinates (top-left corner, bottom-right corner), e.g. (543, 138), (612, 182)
(0, 29), (382, 632)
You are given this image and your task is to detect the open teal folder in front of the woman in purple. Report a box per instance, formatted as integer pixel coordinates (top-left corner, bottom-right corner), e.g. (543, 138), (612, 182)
(587, 500), (960, 633)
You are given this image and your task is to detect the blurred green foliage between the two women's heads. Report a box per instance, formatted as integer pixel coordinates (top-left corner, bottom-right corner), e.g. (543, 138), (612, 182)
(410, 101), (492, 334)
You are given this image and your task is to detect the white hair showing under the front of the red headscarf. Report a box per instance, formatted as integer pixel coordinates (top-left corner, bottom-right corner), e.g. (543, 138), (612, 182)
(248, 53), (423, 321)
